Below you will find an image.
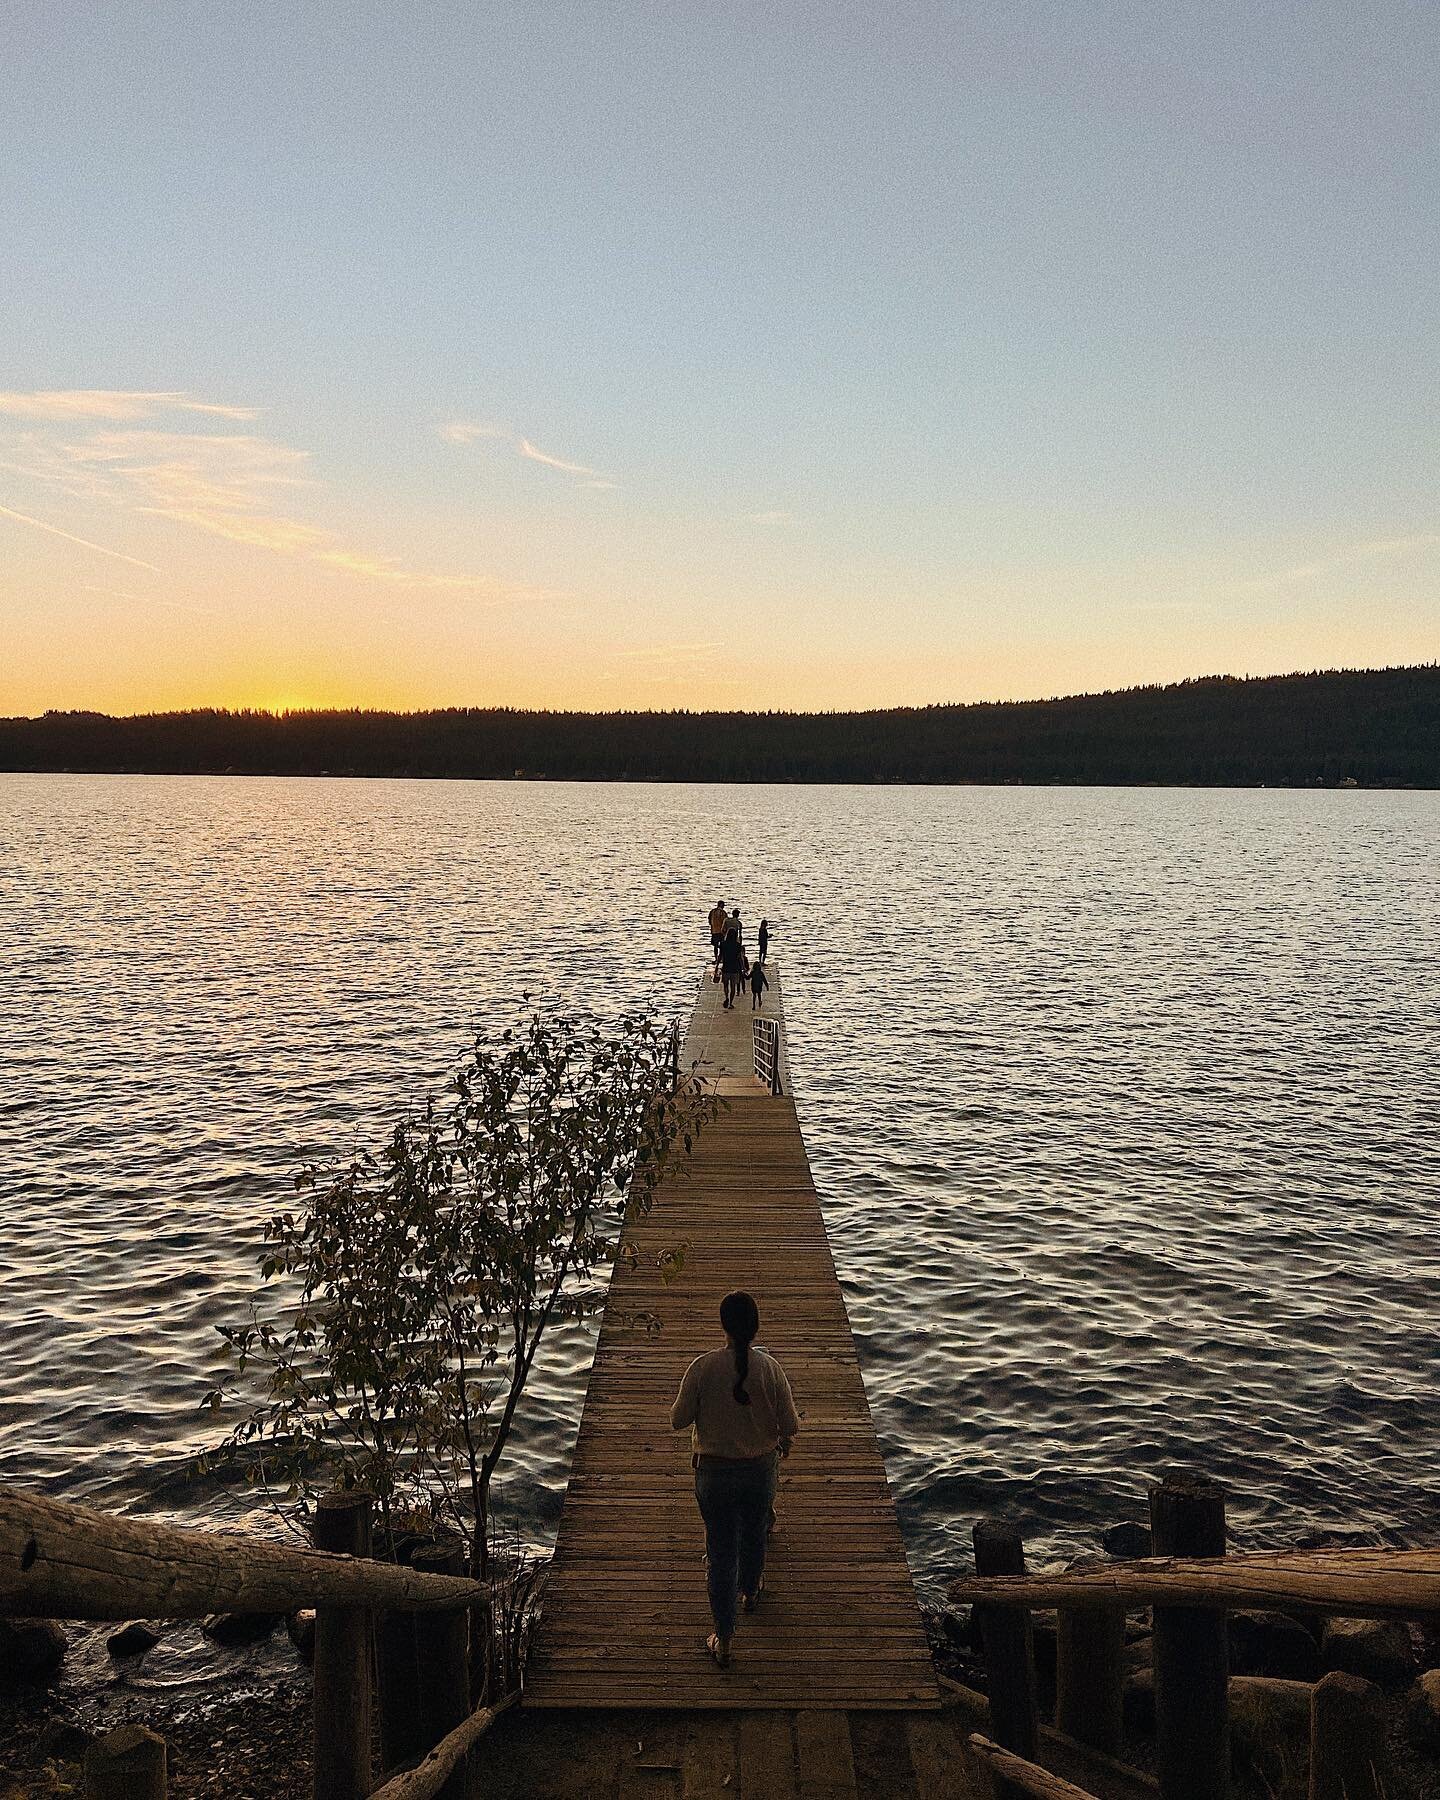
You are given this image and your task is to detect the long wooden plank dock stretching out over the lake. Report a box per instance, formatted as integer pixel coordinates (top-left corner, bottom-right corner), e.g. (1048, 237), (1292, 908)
(524, 965), (940, 1710)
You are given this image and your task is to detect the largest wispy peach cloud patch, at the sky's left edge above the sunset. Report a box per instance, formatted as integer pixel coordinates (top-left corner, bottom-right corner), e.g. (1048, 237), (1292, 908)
(0, 389), (538, 601)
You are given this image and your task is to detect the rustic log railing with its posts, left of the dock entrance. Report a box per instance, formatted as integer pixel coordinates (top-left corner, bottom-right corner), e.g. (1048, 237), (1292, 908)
(0, 1485), (517, 1800)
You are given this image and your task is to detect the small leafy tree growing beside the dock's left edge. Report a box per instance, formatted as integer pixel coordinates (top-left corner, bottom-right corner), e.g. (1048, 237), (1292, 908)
(207, 1012), (718, 1605)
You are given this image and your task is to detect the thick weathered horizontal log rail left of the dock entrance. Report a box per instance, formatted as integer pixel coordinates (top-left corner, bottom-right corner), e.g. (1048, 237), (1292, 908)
(0, 1483), (486, 1618)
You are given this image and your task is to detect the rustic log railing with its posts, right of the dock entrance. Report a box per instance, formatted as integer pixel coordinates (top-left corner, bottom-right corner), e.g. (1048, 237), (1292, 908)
(949, 1476), (1440, 1800)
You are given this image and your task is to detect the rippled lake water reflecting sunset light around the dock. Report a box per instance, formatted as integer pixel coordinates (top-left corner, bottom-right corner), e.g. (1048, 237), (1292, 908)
(0, 776), (1440, 1605)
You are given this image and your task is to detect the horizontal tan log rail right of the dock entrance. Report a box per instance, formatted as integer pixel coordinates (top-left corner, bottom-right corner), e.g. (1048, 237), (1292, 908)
(949, 1550), (1440, 1618)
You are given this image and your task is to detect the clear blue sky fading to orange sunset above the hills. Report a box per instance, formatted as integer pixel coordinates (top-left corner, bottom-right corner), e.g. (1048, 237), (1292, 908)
(0, 0), (1440, 715)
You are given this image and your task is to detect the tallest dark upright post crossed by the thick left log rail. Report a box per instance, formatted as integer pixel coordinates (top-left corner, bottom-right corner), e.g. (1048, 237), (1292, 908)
(313, 1489), (374, 1800)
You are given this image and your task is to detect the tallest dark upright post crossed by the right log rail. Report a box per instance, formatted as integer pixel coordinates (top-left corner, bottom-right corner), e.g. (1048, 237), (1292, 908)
(1150, 1472), (1229, 1800)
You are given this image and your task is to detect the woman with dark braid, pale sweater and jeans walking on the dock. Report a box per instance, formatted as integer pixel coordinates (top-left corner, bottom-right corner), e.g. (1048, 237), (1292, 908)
(670, 1292), (799, 1669)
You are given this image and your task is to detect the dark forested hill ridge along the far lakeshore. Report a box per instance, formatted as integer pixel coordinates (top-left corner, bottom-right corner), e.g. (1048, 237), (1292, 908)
(0, 664), (1440, 788)
